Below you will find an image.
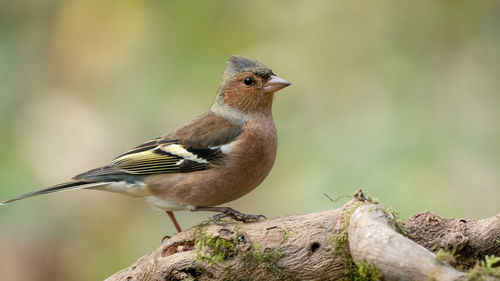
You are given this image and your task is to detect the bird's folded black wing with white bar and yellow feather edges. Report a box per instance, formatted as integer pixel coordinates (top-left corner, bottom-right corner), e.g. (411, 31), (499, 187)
(74, 127), (241, 181)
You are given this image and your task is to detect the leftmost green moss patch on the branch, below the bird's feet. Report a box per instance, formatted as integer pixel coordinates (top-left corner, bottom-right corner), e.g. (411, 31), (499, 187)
(194, 228), (236, 266)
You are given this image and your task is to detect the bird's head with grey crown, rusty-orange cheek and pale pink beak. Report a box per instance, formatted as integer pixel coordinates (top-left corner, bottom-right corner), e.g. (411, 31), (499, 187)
(214, 56), (290, 113)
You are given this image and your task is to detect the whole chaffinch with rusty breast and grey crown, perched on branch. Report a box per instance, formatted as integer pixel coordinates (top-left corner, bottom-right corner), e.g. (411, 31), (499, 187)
(0, 56), (290, 232)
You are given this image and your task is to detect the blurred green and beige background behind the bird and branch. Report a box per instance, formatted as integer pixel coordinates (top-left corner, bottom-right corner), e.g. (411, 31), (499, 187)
(0, 0), (500, 280)
